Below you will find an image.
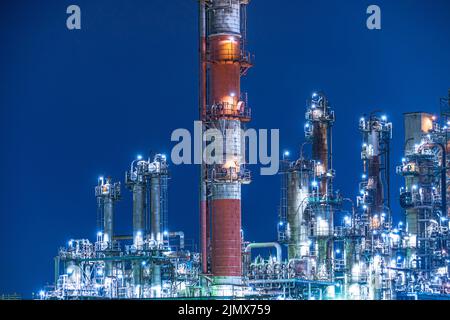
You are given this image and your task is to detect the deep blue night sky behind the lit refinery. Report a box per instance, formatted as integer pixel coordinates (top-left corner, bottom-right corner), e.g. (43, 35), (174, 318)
(0, 0), (450, 297)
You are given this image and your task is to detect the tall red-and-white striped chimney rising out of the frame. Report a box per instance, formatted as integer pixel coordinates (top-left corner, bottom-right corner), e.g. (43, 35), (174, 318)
(199, 0), (251, 285)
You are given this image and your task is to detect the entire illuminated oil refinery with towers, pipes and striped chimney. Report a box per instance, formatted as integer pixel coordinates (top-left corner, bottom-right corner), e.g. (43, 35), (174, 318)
(38, 0), (450, 300)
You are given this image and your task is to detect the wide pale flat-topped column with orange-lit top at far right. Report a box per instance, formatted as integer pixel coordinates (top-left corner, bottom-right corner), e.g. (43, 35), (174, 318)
(397, 113), (447, 272)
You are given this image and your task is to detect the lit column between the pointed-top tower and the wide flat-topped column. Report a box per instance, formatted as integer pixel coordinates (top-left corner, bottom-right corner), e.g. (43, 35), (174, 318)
(352, 114), (392, 300)
